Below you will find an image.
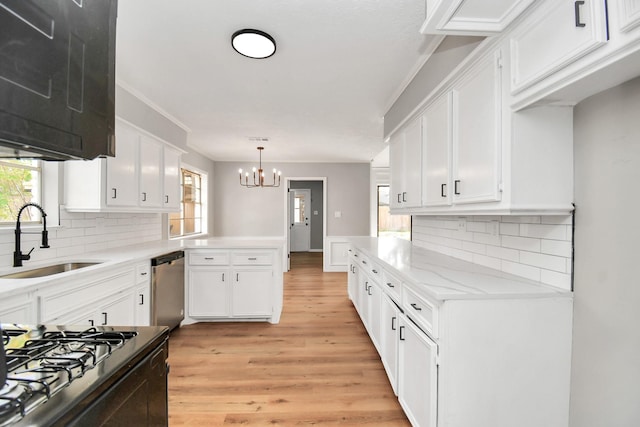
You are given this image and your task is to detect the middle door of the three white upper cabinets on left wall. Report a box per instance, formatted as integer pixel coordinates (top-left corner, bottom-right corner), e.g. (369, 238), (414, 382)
(139, 135), (163, 207)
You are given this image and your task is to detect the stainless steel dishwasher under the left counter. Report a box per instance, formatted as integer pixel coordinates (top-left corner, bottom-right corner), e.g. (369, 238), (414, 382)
(151, 251), (184, 329)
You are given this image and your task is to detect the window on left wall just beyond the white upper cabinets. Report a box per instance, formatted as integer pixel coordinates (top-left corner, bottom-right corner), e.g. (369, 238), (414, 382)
(169, 169), (204, 238)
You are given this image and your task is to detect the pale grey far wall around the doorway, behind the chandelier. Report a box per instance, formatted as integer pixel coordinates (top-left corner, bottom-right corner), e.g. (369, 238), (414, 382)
(213, 162), (369, 237)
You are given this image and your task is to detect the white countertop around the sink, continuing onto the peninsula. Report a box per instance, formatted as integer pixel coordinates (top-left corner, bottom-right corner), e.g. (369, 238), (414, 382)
(0, 237), (286, 297)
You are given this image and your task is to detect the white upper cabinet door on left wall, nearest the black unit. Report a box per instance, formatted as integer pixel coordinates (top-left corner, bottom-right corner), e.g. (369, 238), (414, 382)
(107, 121), (140, 206)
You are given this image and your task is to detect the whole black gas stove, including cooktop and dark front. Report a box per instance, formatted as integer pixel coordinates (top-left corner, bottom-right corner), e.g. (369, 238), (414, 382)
(0, 325), (168, 426)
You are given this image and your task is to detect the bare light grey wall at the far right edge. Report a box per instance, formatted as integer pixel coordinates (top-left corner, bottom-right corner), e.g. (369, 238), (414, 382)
(570, 79), (640, 427)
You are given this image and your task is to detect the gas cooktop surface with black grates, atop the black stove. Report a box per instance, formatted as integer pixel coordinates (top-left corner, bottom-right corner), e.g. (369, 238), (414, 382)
(0, 325), (167, 426)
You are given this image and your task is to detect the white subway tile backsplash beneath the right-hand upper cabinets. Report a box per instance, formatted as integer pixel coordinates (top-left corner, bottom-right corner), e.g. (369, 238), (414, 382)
(412, 215), (573, 290)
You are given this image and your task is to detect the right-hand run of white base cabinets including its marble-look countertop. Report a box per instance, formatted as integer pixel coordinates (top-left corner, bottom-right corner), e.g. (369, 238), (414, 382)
(352, 238), (573, 427)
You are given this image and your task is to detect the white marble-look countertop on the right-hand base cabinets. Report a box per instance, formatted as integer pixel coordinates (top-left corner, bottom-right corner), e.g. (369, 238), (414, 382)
(350, 237), (573, 301)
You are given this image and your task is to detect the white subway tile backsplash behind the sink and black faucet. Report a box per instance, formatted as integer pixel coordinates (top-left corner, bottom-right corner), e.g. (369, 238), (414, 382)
(0, 208), (162, 268)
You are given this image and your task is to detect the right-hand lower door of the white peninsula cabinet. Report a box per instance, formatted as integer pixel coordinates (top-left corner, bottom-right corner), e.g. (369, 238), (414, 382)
(231, 267), (273, 316)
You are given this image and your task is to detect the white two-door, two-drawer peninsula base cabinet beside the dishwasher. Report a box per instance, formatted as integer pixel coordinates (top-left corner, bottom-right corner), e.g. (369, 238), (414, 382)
(186, 249), (278, 323)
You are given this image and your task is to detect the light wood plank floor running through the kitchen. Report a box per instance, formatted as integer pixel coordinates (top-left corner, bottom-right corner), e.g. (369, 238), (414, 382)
(169, 253), (409, 426)
